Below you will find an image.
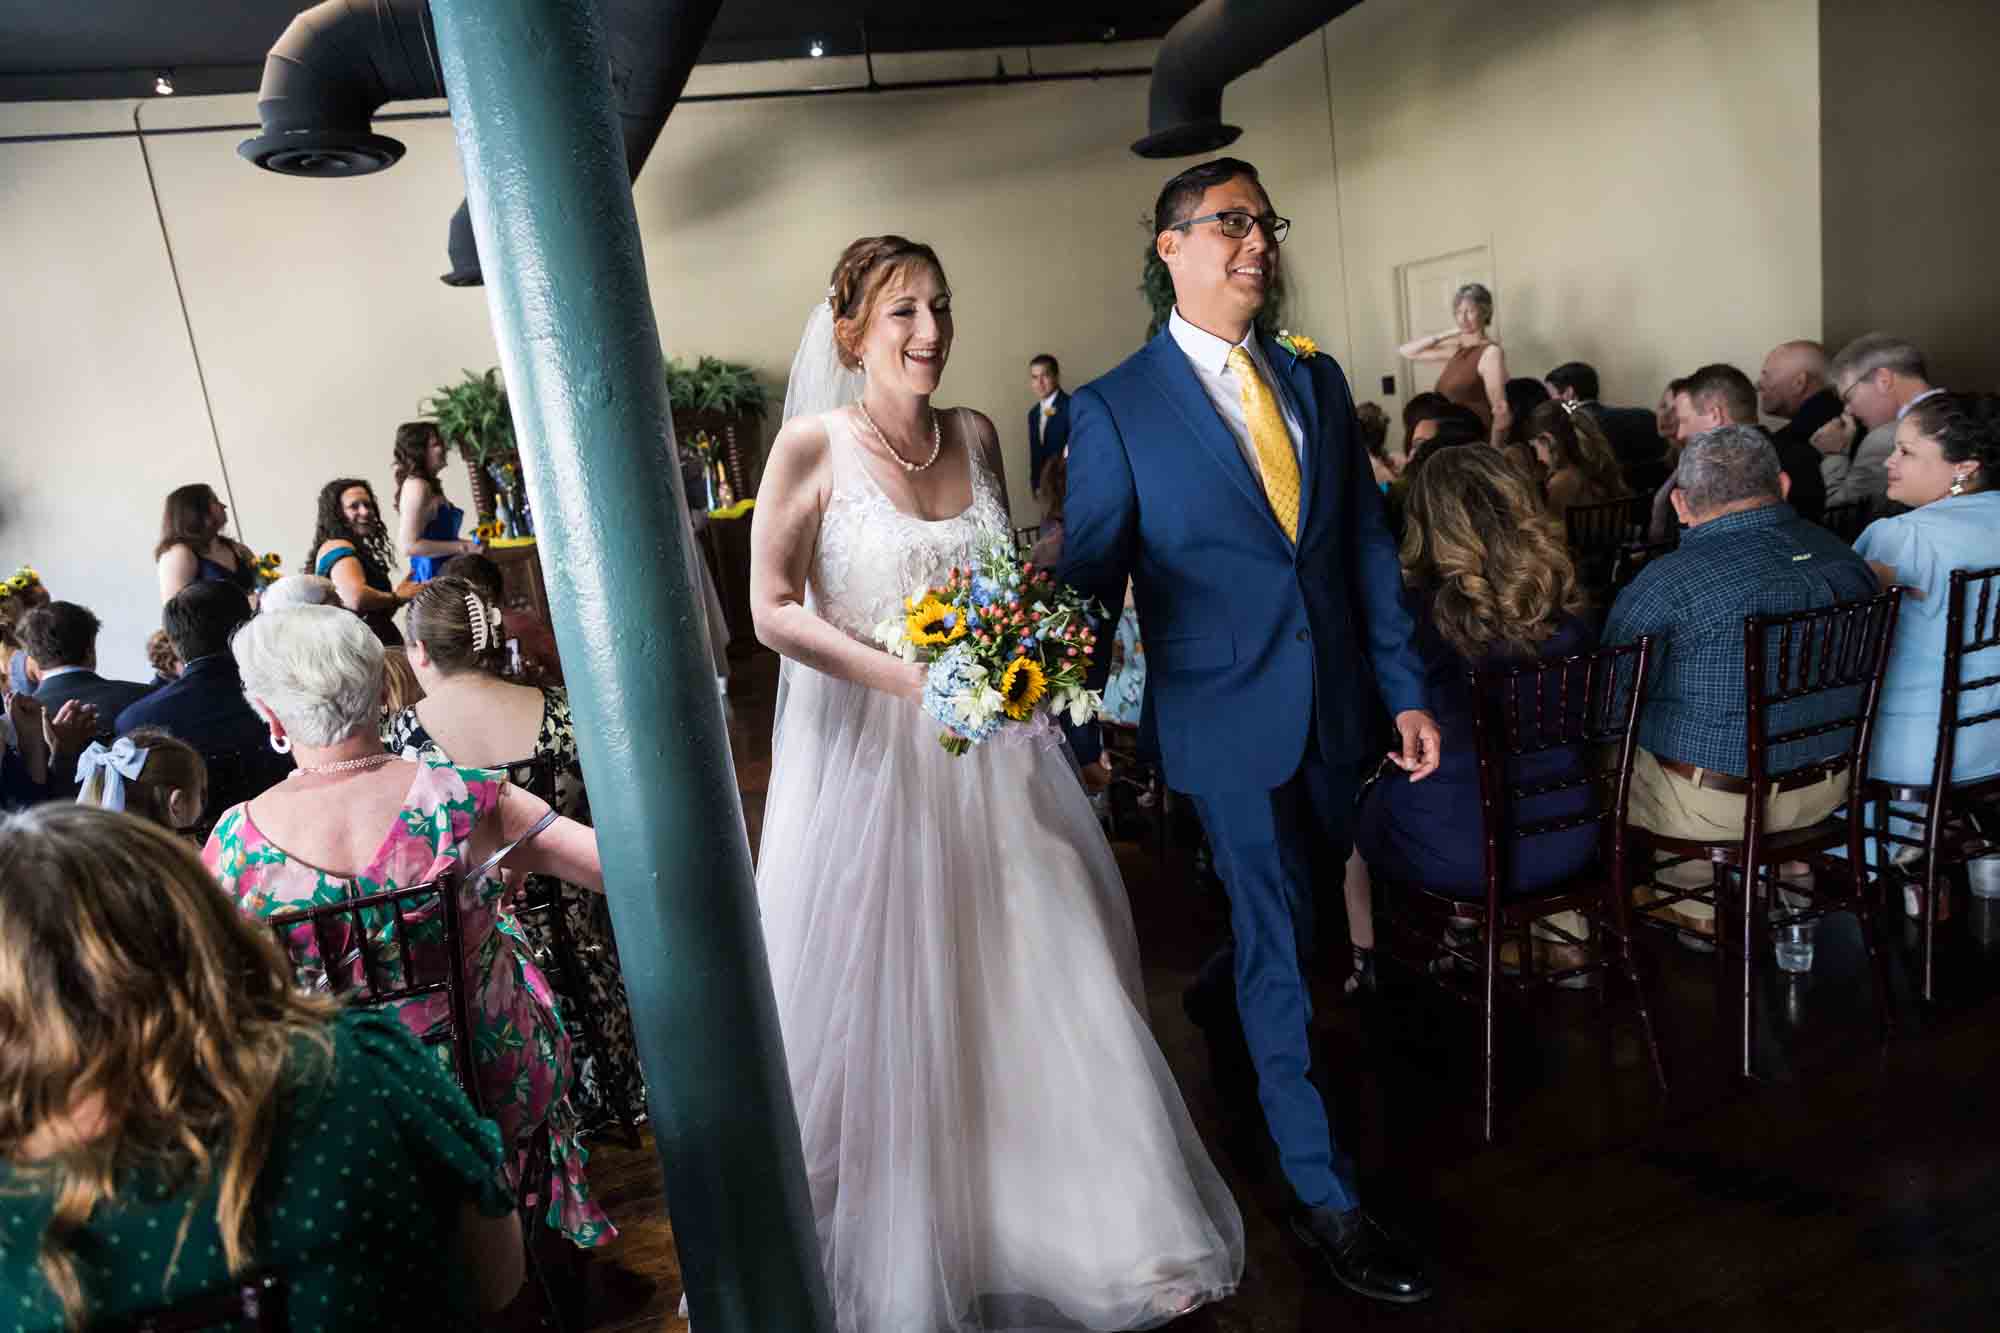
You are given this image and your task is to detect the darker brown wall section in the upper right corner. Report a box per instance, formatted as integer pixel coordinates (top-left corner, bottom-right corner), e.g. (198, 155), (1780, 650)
(1820, 0), (2000, 388)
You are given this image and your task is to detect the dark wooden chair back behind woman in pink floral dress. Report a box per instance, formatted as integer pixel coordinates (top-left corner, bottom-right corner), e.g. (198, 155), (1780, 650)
(264, 871), (482, 1107)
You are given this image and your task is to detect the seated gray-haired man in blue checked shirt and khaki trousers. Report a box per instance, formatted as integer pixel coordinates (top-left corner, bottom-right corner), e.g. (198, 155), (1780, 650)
(1604, 426), (1876, 935)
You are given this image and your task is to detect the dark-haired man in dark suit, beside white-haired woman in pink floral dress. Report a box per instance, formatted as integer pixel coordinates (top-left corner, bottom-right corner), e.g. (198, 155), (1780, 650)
(116, 582), (292, 823)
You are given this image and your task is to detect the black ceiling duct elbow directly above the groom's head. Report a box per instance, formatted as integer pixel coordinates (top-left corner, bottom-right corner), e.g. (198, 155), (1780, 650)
(1132, 0), (1360, 158)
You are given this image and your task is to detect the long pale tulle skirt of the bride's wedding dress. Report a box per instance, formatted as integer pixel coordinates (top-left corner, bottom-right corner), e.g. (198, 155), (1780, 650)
(758, 664), (1244, 1333)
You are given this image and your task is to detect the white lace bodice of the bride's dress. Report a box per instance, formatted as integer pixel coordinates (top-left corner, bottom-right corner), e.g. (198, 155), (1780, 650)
(808, 408), (1010, 644)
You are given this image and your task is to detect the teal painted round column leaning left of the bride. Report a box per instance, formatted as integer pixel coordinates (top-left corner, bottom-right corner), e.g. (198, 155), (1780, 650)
(430, 0), (834, 1333)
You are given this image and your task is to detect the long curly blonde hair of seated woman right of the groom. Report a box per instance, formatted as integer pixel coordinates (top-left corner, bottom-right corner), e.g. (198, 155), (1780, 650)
(1402, 446), (1586, 660)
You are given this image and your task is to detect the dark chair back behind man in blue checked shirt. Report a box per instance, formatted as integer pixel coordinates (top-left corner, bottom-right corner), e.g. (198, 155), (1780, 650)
(1744, 588), (1902, 787)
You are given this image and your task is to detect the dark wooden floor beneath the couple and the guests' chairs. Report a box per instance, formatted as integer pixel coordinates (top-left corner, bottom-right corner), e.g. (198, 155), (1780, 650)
(556, 656), (2000, 1333)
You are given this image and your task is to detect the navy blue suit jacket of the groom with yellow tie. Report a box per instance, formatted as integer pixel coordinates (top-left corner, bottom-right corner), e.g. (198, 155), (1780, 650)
(1062, 330), (1426, 795)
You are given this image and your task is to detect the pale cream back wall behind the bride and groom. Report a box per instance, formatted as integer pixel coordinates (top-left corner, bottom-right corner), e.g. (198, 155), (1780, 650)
(0, 0), (1820, 675)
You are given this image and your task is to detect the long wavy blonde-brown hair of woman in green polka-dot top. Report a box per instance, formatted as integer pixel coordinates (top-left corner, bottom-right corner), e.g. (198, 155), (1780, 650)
(0, 805), (334, 1327)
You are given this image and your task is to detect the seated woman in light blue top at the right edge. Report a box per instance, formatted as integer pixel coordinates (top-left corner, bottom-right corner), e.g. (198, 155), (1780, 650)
(1854, 394), (2000, 785)
